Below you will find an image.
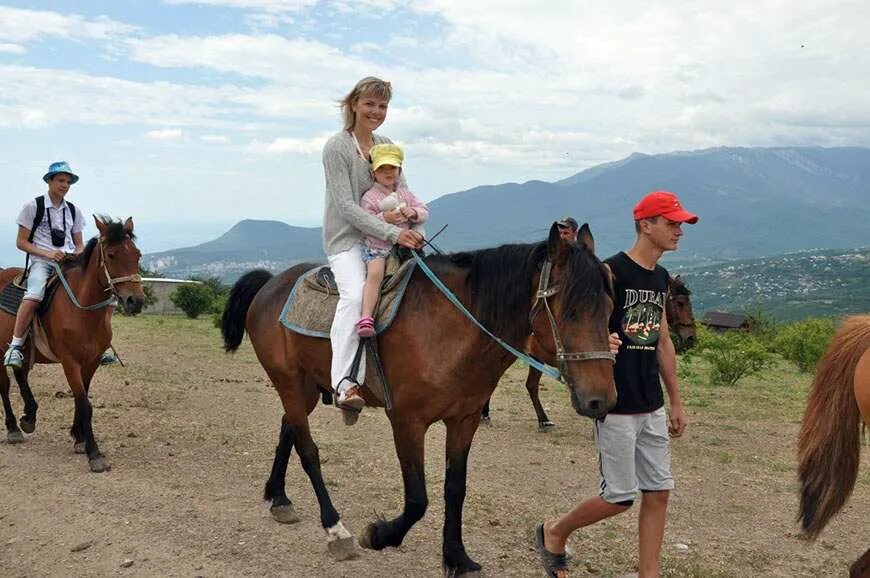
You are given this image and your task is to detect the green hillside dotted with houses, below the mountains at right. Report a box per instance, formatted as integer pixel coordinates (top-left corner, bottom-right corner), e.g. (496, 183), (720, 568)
(670, 247), (870, 321)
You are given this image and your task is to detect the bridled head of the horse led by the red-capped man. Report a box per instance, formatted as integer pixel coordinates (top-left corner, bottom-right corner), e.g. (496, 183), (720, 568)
(530, 223), (616, 417)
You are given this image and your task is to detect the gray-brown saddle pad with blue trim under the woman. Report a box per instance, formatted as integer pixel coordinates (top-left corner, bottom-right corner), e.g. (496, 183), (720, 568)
(280, 261), (416, 339)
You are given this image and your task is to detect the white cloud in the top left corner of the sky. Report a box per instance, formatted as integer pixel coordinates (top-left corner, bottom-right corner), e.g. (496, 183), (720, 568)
(0, 6), (138, 43)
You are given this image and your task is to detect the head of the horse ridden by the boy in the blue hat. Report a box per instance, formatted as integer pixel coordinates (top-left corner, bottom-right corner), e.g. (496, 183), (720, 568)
(94, 215), (145, 315)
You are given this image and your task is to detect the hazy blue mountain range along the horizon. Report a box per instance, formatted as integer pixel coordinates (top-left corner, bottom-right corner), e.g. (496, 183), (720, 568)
(143, 148), (870, 280)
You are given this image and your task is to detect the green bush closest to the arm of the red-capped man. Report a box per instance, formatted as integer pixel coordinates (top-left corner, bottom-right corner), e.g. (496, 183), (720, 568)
(696, 327), (773, 385)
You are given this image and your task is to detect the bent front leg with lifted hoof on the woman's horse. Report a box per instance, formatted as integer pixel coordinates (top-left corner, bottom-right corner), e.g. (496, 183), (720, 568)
(360, 416), (430, 550)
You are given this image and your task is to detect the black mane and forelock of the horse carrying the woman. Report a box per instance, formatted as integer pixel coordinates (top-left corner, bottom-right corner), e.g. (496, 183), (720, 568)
(427, 241), (607, 343)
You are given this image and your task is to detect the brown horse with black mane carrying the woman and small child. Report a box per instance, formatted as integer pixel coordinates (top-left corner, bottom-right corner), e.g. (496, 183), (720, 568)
(222, 223), (616, 575)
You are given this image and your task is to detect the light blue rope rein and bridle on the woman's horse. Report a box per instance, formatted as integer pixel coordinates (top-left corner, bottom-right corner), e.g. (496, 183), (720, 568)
(411, 251), (615, 383)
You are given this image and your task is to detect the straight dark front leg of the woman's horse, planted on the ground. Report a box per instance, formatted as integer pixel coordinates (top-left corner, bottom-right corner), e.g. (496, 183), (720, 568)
(442, 416), (480, 576)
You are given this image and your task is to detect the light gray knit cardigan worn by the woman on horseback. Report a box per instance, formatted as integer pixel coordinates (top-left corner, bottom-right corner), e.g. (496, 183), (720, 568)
(323, 130), (404, 255)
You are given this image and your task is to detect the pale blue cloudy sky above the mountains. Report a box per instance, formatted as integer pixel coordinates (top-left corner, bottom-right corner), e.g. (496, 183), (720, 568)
(0, 0), (870, 258)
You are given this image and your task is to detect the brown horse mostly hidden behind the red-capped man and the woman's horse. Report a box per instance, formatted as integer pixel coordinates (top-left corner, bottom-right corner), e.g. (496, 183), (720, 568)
(480, 275), (696, 432)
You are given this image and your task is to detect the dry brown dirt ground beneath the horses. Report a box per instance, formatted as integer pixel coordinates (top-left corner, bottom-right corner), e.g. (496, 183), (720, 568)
(0, 317), (870, 577)
